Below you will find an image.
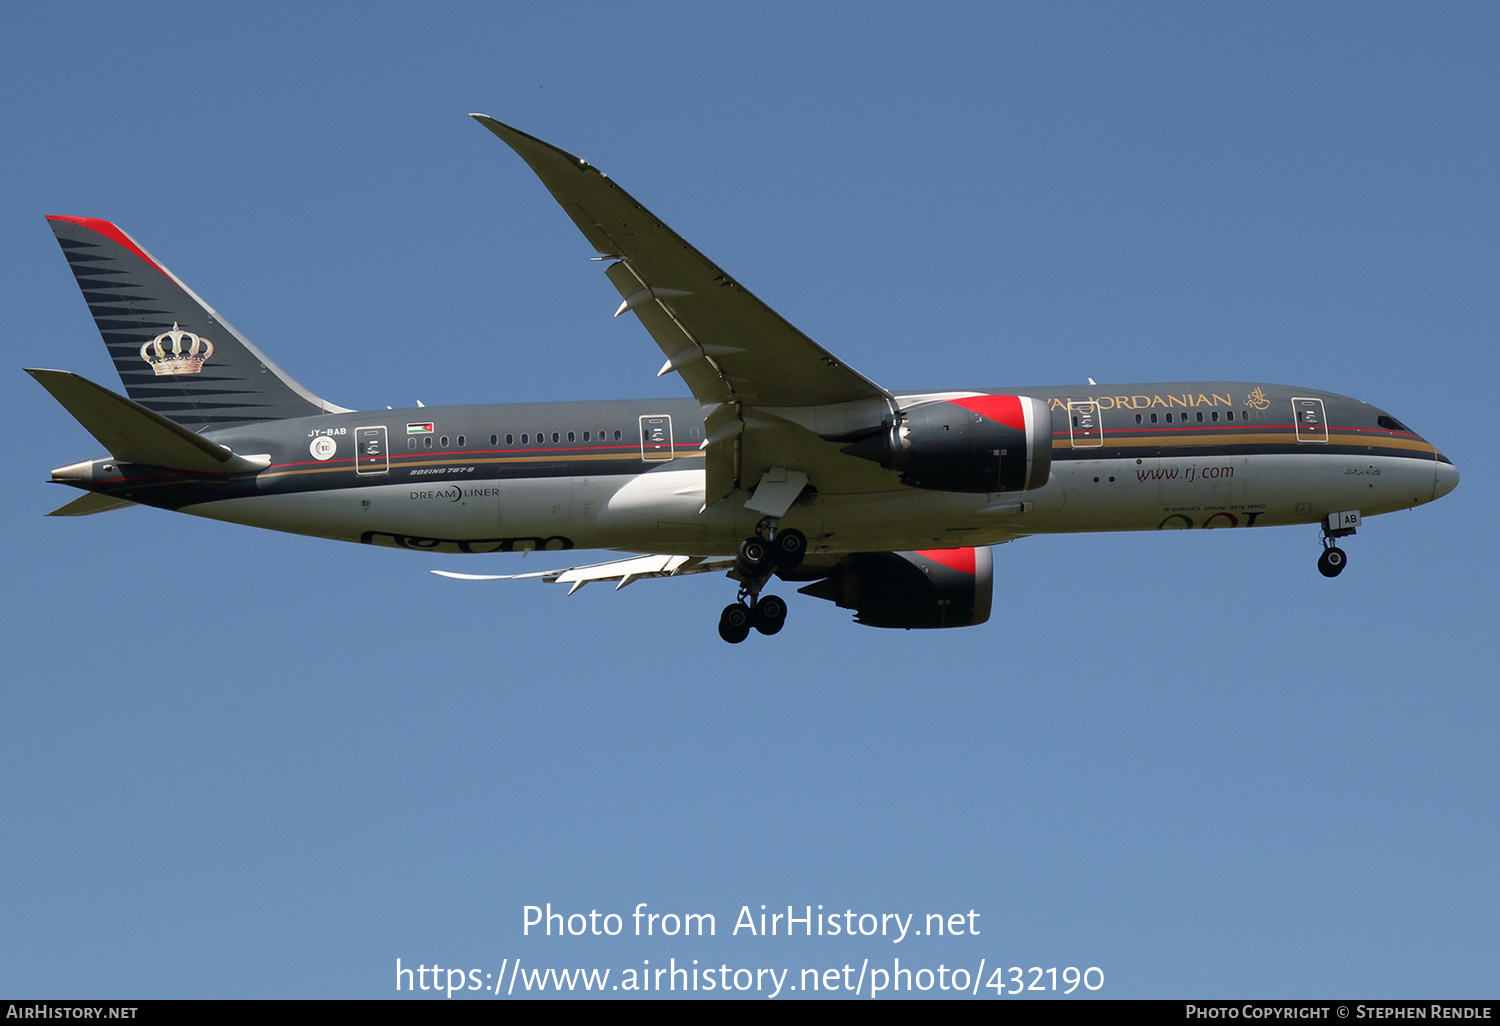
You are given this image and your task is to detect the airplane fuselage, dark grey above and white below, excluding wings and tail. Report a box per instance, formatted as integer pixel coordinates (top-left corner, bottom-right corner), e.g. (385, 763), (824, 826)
(59, 381), (1458, 557)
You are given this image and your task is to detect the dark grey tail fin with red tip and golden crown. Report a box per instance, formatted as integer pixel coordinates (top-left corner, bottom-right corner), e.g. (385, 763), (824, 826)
(47, 216), (348, 431)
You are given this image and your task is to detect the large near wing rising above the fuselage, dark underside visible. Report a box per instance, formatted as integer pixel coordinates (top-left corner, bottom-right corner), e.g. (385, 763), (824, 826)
(473, 114), (894, 506)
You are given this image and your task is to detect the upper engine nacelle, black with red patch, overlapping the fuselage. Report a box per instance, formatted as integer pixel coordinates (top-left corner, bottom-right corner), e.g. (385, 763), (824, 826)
(843, 396), (1052, 492)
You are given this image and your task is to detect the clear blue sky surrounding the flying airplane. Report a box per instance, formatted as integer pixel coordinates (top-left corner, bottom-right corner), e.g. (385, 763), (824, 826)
(0, 3), (1500, 998)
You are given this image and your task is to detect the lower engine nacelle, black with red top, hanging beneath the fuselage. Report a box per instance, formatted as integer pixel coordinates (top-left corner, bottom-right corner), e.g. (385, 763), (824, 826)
(800, 546), (995, 630)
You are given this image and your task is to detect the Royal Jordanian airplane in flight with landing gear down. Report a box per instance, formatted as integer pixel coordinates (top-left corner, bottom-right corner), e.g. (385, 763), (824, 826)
(29, 114), (1458, 644)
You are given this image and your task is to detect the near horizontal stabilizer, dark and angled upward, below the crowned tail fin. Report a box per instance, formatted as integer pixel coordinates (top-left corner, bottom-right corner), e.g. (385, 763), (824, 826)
(26, 368), (270, 474)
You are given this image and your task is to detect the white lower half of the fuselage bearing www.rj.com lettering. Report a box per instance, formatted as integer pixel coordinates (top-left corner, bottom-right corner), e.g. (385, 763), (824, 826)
(182, 453), (1448, 555)
